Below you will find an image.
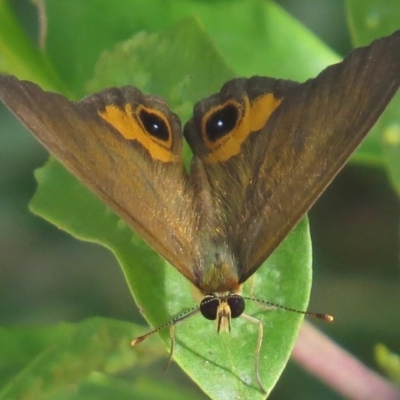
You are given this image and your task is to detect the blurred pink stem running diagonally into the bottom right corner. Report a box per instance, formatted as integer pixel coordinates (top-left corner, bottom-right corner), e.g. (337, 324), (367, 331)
(292, 321), (400, 400)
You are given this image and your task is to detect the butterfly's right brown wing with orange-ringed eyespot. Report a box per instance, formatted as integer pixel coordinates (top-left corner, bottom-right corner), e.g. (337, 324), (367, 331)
(185, 31), (400, 282)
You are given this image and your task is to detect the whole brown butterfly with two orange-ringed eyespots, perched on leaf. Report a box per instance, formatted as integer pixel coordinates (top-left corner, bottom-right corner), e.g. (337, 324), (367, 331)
(0, 31), (400, 388)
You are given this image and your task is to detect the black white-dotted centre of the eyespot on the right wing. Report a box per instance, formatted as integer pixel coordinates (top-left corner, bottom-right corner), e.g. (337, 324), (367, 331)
(206, 104), (239, 142)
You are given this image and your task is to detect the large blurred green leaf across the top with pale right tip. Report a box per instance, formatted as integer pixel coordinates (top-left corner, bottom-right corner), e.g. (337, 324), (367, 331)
(46, 0), (340, 94)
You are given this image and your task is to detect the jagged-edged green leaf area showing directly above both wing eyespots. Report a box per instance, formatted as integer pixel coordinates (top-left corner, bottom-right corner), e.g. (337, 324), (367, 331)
(87, 18), (234, 120)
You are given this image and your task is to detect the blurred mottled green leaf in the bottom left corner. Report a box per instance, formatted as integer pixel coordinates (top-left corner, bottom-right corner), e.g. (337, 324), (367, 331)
(0, 318), (158, 400)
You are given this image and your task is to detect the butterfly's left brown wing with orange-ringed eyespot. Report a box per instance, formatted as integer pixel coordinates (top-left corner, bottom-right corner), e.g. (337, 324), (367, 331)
(0, 75), (196, 280)
